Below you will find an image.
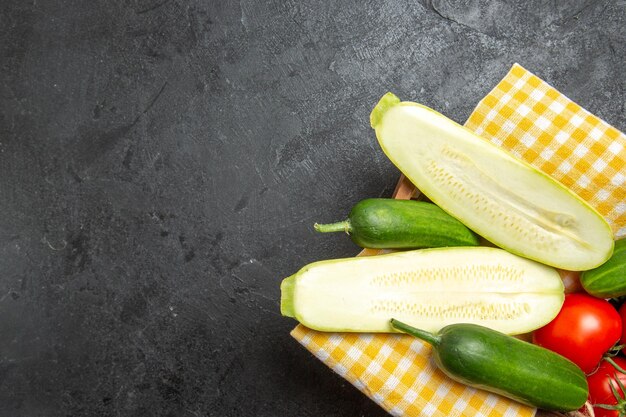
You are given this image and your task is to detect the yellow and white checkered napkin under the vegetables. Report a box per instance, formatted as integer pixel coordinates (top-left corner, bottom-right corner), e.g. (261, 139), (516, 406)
(291, 64), (626, 417)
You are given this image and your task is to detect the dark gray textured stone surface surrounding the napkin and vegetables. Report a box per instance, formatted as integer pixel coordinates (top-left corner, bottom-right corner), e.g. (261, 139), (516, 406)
(0, 0), (626, 417)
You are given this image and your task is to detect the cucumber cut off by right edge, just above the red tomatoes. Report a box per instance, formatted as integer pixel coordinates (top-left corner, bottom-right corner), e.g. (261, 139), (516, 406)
(580, 238), (626, 298)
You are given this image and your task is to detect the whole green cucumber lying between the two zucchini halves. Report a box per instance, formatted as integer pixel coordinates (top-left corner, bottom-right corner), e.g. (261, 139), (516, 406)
(315, 198), (479, 249)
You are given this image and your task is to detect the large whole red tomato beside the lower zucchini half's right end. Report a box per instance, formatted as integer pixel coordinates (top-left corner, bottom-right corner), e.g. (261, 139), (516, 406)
(533, 294), (622, 374)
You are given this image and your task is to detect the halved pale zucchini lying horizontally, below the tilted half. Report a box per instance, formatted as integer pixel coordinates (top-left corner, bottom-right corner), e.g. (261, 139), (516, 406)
(281, 246), (565, 334)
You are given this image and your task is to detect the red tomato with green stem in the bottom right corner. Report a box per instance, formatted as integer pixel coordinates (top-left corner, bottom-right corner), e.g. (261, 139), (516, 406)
(587, 357), (626, 417)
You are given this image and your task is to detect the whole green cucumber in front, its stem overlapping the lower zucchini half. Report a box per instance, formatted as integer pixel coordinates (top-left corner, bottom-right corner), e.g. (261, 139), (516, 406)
(391, 319), (588, 411)
